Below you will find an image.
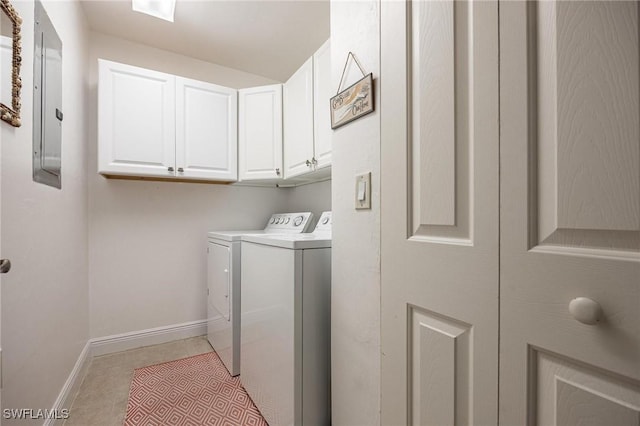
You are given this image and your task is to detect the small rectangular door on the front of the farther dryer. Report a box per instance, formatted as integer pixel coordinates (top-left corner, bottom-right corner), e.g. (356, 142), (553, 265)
(207, 242), (231, 321)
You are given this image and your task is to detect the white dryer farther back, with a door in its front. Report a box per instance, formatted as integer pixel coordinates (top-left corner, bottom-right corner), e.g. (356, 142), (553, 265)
(207, 212), (313, 376)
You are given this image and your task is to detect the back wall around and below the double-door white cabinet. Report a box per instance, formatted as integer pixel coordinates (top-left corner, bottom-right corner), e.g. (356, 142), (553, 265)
(87, 33), (298, 337)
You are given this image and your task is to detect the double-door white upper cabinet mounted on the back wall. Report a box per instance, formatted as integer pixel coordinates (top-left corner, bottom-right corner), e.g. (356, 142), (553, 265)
(98, 59), (237, 181)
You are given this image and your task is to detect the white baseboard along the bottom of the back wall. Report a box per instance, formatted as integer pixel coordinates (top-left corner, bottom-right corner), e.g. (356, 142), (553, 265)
(90, 320), (207, 356)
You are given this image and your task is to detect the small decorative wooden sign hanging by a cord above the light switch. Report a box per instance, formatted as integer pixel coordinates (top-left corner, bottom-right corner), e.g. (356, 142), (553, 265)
(329, 52), (373, 129)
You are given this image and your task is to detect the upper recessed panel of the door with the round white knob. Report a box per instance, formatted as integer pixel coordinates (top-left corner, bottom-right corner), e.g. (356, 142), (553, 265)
(529, 2), (640, 249)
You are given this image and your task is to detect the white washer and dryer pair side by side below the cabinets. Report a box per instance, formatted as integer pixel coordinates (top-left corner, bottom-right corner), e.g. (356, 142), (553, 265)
(209, 212), (332, 426)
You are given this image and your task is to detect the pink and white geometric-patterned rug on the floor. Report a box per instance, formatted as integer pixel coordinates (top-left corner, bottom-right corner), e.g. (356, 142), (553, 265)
(124, 352), (268, 426)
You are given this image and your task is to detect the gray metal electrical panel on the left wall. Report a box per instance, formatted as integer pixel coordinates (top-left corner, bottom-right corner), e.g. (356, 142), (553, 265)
(33, 1), (62, 188)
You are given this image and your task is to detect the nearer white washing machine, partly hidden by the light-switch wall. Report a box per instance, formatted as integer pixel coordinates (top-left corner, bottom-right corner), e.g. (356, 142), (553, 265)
(240, 212), (331, 426)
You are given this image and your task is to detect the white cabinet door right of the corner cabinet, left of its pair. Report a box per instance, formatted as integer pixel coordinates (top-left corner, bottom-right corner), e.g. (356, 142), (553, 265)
(283, 58), (313, 179)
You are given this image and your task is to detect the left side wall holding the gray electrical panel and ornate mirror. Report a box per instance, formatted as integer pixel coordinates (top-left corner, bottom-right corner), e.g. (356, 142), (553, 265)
(0, 0), (89, 425)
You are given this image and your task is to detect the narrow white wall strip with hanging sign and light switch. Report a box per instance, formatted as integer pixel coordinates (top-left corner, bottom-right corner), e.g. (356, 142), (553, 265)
(331, 0), (380, 426)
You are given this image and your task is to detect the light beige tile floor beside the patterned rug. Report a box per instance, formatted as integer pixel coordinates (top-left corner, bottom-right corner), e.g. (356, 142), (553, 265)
(64, 336), (212, 426)
